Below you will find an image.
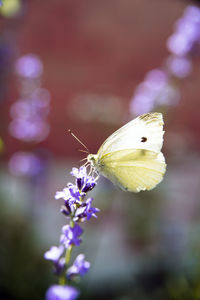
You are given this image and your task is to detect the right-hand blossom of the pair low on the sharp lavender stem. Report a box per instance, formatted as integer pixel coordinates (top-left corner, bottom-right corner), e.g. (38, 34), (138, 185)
(67, 254), (90, 278)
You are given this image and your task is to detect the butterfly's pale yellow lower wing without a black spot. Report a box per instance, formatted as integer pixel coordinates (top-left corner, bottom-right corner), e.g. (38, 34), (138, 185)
(98, 149), (166, 192)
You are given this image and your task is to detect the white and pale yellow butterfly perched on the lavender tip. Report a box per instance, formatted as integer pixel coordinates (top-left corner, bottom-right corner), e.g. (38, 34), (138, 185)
(87, 112), (166, 192)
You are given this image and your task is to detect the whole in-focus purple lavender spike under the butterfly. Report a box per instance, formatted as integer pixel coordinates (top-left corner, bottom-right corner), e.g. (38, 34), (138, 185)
(44, 166), (99, 300)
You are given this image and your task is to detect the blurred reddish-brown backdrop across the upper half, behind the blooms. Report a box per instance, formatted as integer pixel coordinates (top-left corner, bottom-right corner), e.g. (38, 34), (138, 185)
(2, 0), (200, 157)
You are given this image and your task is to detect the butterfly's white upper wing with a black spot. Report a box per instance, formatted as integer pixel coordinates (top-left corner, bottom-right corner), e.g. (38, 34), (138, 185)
(97, 112), (164, 158)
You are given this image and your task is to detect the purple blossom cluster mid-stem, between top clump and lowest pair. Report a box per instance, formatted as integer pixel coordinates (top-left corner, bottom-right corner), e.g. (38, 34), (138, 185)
(60, 224), (83, 248)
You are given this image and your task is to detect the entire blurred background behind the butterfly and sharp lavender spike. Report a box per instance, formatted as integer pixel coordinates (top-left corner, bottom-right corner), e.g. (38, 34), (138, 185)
(0, 0), (200, 300)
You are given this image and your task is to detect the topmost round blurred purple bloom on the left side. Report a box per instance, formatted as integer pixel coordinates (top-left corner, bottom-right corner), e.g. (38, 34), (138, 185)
(15, 54), (43, 79)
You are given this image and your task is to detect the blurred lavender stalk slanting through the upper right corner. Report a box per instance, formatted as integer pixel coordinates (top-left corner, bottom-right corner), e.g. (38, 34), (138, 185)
(130, 5), (200, 115)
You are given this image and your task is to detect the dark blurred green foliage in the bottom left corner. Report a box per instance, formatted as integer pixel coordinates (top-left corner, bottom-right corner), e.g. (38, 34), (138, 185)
(0, 197), (51, 300)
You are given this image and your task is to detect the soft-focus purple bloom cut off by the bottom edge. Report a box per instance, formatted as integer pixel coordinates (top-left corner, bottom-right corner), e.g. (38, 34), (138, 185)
(45, 285), (79, 300)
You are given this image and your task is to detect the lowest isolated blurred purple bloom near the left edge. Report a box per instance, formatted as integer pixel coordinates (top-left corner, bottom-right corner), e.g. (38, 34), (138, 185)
(8, 151), (43, 176)
